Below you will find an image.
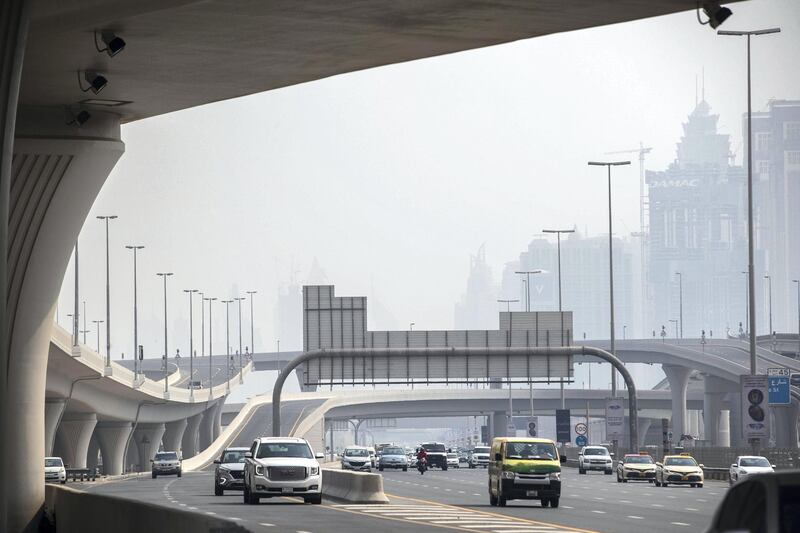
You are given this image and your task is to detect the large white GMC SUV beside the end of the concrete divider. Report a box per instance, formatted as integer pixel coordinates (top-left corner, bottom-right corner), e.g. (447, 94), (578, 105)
(244, 437), (323, 505)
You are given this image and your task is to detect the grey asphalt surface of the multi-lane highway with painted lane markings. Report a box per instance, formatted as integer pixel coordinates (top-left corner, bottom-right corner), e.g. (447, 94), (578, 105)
(76, 468), (727, 533)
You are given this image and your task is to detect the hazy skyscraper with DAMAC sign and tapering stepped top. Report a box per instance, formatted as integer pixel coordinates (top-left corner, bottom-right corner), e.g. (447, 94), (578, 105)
(646, 100), (758, 338)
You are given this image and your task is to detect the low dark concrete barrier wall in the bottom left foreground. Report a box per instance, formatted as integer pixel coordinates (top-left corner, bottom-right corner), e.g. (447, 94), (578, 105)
(42, 484), (247, 533)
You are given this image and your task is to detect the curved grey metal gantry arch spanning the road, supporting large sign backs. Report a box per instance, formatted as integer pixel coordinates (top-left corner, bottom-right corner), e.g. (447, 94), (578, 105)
(272, 346), (639, 449)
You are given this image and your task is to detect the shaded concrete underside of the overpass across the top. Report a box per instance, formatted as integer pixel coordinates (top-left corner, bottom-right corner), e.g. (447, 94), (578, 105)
(20, 0), (744, 122)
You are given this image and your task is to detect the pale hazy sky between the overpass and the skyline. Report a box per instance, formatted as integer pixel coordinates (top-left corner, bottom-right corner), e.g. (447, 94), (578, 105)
(54, 0), (800, 357)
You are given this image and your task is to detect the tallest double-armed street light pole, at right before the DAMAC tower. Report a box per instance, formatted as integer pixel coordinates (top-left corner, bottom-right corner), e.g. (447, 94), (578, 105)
(717, 28), (781, 376)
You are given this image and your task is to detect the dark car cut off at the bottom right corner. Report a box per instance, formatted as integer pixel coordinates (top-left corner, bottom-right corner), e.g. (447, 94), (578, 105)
(707, 470), (800, 533)
